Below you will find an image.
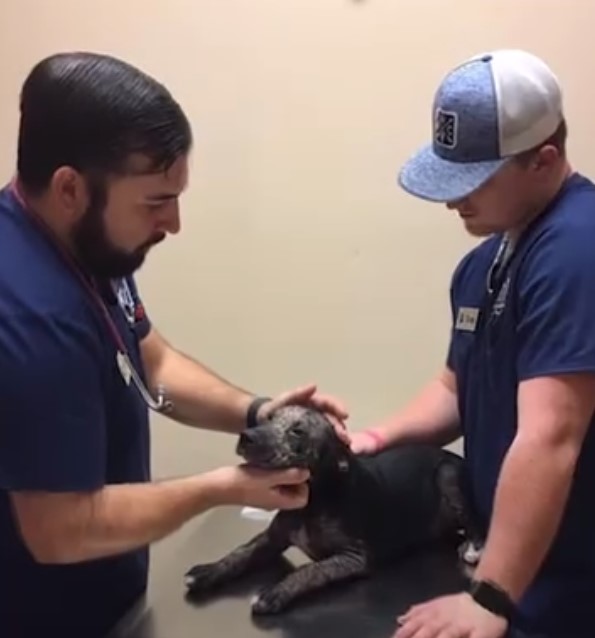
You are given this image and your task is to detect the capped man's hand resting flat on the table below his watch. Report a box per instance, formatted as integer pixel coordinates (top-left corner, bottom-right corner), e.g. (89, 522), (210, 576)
(394, 593), (508, 638)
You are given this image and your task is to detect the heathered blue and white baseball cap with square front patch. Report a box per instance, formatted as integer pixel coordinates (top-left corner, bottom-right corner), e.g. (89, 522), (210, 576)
(398, 49), (563, 202)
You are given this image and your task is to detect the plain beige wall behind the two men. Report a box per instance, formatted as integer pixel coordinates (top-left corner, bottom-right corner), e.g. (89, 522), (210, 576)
(0, 0), (595, 592)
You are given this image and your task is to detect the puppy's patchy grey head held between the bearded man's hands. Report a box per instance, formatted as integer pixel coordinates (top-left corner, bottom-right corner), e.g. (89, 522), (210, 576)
(236, 405), (349, 474)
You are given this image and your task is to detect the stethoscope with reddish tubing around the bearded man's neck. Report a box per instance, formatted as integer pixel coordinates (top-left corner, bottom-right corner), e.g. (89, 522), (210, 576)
(10, 179), (173, 413)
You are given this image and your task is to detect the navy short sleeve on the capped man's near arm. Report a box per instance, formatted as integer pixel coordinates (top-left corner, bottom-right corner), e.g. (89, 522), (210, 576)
(517, 224), (595, 380)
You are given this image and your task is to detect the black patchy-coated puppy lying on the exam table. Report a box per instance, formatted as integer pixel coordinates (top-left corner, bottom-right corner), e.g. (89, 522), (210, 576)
(185, 406), (478, 614)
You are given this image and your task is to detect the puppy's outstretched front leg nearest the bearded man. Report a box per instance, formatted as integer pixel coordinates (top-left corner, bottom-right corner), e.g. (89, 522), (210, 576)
(184, 513), (291, 595)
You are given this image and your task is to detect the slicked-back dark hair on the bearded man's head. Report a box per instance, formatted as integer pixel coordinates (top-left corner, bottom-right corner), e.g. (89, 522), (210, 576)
(17, 52), (192, 192)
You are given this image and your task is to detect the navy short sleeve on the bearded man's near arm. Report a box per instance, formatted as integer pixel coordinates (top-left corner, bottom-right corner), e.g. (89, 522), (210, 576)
(0, 311), (106, 491)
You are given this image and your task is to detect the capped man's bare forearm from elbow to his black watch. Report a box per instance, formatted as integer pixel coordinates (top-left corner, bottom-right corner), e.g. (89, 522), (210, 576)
(474, 436), (576, 601)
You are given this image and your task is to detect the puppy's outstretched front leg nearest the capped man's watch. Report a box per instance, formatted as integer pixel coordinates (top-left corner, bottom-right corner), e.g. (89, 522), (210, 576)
(252, 550), (368, 614)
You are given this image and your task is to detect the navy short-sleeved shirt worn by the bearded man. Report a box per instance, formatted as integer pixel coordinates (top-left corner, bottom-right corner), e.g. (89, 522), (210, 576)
(0, 182), (150, 638)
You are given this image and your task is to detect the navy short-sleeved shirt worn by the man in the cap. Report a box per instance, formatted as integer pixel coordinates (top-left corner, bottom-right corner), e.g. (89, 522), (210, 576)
(448, 174), (595, 638)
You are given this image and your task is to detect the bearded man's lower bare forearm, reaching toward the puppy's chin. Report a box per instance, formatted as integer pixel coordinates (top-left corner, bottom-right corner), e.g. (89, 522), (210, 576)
(16, 473), (230, 563)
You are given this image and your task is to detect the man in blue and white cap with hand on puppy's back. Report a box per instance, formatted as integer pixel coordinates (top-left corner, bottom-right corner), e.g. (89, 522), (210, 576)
(353, 50), (595, 638)
